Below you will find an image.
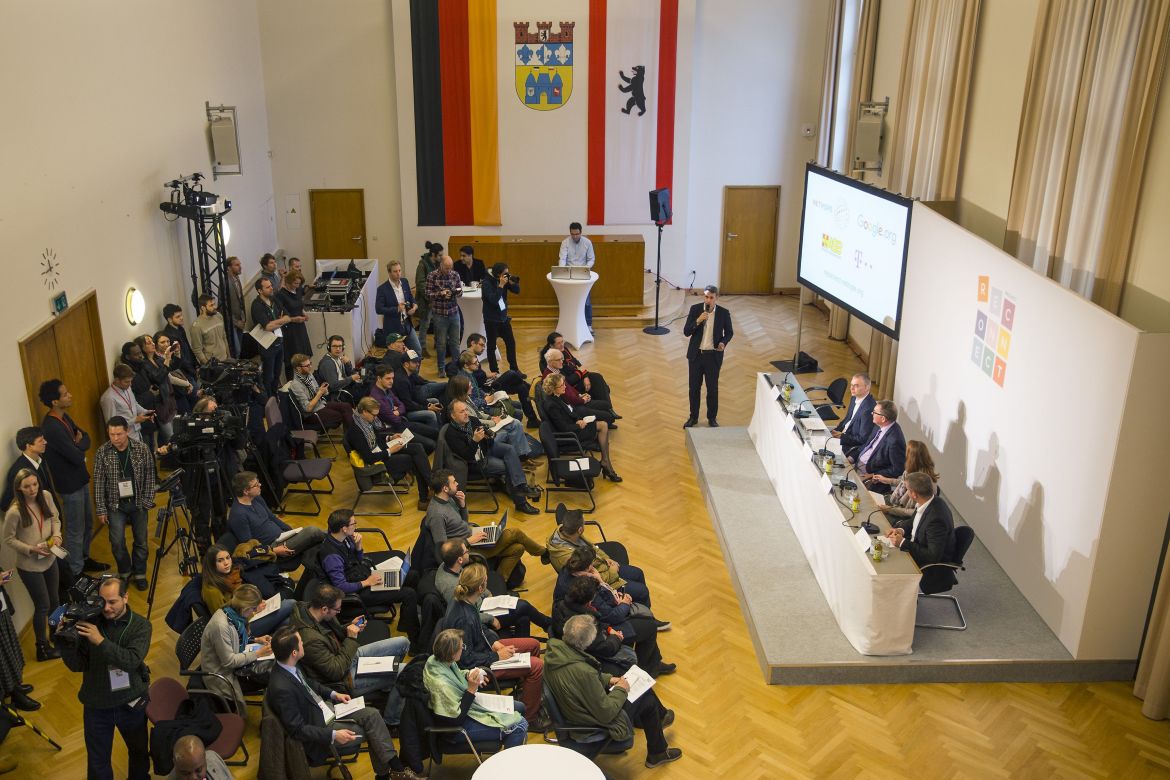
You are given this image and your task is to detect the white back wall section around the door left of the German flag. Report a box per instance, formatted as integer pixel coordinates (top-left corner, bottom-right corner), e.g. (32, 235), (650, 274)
(252, 0), (402, 275)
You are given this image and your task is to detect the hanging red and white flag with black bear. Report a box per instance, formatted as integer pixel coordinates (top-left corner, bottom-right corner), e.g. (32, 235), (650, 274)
(586, 0), (679, 225)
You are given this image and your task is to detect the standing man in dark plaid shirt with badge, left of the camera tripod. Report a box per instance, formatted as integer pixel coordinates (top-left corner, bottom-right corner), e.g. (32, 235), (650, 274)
(94, 416), (158, 591)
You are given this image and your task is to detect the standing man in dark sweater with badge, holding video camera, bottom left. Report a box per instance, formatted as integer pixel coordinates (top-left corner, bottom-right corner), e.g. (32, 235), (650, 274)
(57, 577), (151, 780)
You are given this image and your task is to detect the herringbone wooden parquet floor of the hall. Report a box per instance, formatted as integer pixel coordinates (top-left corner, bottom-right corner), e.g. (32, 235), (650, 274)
(9, 297), (1170, 779)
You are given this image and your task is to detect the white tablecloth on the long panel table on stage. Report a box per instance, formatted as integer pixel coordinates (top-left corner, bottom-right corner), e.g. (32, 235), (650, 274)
(748, 374), (921, 655)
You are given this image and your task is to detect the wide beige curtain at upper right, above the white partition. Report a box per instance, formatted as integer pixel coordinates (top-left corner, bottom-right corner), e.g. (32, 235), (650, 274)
(1005, 0), (1170, 312)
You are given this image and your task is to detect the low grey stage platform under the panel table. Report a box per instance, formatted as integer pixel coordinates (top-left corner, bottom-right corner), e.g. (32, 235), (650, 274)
(687, 428), (1135, 685)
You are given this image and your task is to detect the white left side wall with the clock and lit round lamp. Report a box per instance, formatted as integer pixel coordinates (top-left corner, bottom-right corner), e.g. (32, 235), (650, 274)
(0, 0), (275, 616)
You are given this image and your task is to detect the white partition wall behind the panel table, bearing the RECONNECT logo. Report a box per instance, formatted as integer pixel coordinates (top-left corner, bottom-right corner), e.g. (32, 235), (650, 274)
(895, 203), (1170, 660)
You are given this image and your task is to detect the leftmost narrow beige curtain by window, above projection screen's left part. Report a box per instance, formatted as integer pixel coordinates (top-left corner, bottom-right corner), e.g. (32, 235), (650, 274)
(817, 0), (881, 341)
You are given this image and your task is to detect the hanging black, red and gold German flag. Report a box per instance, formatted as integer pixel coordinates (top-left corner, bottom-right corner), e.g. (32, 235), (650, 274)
(411, 0), (501, 225)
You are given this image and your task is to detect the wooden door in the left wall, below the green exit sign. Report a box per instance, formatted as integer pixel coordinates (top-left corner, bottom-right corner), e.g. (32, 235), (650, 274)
(20, 292), (110, 446)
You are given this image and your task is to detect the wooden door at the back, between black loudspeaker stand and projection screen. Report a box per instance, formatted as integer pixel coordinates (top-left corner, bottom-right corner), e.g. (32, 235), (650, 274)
(720, 186), (780, 295)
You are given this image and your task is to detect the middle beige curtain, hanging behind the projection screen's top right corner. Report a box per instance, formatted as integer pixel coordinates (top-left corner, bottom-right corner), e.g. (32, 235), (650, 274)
(869, 0), (980, 398)
